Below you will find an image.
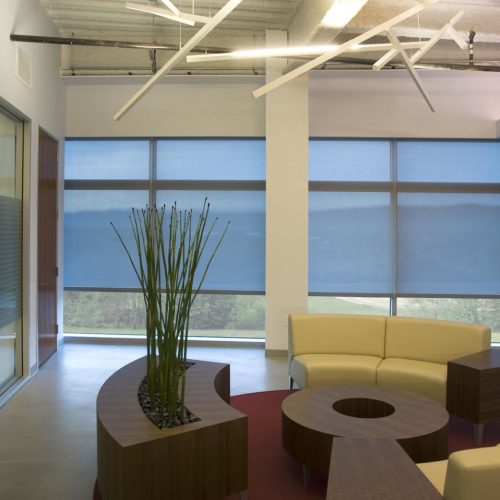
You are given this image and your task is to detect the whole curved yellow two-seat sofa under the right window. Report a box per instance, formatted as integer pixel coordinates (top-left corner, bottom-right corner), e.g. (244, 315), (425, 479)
(288, 314), (491, 405)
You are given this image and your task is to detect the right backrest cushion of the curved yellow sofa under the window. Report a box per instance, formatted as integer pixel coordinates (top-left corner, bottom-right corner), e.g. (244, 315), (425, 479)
(385, 316), (491, 363)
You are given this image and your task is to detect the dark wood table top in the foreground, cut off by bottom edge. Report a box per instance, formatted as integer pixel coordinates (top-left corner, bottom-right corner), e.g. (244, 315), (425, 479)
(326, 437), (443, 500)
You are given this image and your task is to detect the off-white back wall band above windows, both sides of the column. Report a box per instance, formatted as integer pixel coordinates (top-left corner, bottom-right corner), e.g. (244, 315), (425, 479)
(64, 70), (500, 138)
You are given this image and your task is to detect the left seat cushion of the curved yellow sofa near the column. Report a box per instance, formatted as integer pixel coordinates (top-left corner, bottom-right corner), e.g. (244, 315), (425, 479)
(289, 354), (381, 388)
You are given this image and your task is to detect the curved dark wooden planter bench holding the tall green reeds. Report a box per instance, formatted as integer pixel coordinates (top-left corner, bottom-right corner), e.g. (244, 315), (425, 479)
(97, 357), (248, 500)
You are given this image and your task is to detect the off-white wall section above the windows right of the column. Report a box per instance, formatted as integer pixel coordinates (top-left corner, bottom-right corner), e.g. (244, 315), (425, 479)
(310, 70), (500, 138)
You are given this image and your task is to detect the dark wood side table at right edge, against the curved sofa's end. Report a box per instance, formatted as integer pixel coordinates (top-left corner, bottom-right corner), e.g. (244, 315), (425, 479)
(446, 348), (500, 446)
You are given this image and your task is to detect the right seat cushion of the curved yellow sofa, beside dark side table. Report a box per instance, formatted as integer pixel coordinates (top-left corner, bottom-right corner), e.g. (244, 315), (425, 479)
(377, 358), (447, 406)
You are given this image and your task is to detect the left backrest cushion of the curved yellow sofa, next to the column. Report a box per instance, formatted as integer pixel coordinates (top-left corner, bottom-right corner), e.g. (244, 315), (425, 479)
(288, 314), (385, 358)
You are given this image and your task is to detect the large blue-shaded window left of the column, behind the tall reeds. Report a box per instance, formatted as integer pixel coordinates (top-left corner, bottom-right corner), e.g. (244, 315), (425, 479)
(64, 139), (265, 338)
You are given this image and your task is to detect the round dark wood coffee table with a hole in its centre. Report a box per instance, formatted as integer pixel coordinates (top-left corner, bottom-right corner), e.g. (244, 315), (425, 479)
(281, 385), (449, 473)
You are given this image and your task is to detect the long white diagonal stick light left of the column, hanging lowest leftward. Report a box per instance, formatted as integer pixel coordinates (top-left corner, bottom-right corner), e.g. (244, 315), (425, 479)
(113, 0), (242, 121)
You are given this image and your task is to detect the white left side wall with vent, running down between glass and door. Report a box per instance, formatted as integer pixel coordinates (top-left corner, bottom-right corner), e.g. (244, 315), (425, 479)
(0, 0), (65, 390)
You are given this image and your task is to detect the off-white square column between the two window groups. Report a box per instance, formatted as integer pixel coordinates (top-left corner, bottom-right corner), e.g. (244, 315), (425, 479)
(265, 30), (309, 355)
